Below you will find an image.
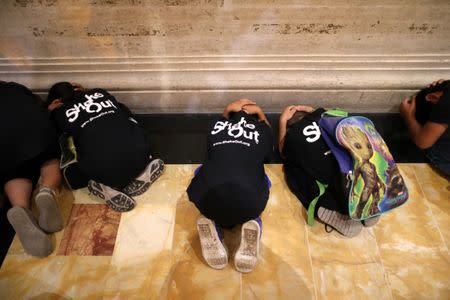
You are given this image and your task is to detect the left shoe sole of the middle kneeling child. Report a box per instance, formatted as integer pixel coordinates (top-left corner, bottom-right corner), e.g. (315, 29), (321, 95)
(197, 215), (228, 270)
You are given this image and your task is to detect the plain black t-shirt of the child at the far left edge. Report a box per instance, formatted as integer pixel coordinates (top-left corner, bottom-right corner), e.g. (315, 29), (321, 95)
(0, 82), (57, 174)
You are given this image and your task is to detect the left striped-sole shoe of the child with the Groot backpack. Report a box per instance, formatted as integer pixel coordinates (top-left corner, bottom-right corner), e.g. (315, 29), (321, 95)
(317, 207), (363, 237)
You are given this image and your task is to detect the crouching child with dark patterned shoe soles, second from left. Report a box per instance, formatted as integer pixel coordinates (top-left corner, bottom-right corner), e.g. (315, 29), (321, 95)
(47, 82), (164, 212)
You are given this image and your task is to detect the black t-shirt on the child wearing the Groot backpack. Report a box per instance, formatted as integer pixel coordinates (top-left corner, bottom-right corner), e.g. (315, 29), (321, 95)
(283, 109), (348, 214)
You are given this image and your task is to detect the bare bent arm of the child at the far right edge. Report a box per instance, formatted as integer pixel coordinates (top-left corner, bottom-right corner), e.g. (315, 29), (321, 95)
(400, 97), (448, 149)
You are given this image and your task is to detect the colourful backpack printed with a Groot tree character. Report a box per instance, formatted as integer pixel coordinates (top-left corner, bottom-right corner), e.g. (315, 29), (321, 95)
(319, 110), (408, 220)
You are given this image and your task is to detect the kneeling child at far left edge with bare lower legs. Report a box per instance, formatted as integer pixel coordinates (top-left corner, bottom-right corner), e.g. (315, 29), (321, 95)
(0, 81), (63, 256)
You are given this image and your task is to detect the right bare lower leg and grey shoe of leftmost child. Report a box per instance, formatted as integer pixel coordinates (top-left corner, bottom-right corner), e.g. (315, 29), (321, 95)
(35, 159), (63, 232)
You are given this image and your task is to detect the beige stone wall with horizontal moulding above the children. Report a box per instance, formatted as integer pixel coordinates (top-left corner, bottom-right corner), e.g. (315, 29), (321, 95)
(0, 0), (450, 113)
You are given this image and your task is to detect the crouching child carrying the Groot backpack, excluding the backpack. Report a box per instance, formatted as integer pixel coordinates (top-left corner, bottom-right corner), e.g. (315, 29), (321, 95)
(278, 105), (379, 237)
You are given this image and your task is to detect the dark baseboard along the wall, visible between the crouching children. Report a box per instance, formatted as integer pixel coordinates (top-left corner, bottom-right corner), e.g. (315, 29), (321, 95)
(137, 113), (426, 164)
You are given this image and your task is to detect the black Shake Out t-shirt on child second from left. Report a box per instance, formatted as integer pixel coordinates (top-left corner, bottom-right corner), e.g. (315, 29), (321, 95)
(54, 89), (150, 187)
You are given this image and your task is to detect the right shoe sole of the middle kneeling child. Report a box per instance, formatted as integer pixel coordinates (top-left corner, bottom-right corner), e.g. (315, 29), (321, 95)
(234, 218), (262, 273)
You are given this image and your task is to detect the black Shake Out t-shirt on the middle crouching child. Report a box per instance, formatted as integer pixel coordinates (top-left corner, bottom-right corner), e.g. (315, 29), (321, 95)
(188, 111), (273, 226)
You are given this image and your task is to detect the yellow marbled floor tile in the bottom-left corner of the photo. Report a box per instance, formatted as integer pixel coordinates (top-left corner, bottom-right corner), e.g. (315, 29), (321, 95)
(0, 256), (111, 299)
